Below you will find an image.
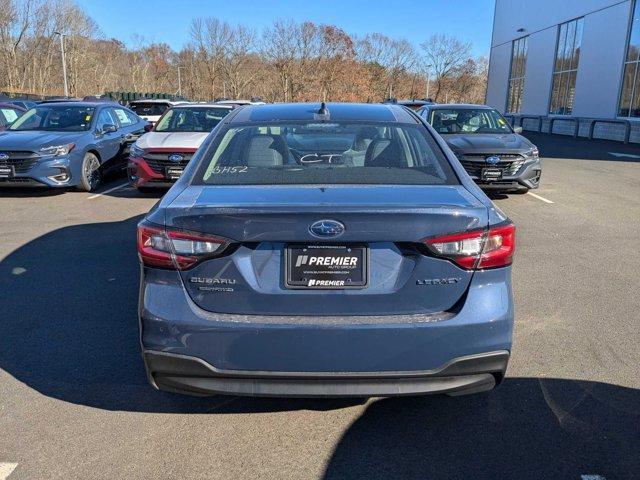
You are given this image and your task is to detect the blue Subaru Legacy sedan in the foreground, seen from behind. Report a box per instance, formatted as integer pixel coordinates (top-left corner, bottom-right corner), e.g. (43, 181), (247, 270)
(138, 103), (515, 397)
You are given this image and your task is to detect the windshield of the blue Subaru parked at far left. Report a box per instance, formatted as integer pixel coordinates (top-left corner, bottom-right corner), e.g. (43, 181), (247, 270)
(9, 105), (95, 132)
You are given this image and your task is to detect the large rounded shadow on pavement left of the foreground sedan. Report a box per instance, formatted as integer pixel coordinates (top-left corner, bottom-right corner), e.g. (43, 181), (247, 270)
(0, 216), (362, 413)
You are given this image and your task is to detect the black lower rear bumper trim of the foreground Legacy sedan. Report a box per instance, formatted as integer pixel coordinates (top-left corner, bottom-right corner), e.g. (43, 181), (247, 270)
(143, 351), (509, 397)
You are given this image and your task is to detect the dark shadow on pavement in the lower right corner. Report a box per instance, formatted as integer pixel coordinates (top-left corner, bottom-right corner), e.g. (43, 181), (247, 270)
(324, 378), (640, 480)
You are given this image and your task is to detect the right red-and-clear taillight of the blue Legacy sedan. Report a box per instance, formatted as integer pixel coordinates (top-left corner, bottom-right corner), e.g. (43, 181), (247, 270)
(424, 223), (516, 270)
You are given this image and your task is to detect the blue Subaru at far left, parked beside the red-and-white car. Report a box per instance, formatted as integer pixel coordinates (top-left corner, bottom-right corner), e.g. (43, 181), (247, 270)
(0, 101), (147, 191)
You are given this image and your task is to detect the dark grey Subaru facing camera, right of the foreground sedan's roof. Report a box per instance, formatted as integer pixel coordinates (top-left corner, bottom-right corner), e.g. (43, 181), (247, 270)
(418, 104), (542, 193)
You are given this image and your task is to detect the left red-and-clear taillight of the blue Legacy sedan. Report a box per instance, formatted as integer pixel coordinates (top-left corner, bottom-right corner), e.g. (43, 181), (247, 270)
(138, 224), (228, 270)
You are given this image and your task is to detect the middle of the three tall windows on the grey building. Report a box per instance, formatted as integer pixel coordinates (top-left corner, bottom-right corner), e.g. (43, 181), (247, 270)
(549, 18), (584, 115)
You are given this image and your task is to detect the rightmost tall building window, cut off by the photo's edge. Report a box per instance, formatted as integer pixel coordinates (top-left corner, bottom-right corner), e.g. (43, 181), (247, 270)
(618, 1), (640, 117)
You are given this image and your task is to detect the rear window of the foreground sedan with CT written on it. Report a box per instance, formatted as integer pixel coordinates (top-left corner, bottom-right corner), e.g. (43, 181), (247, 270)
(195, 122), (458, 185)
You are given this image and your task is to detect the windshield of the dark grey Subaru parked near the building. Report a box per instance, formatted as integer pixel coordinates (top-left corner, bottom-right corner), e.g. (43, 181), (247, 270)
(429, 108), (512, 134)
